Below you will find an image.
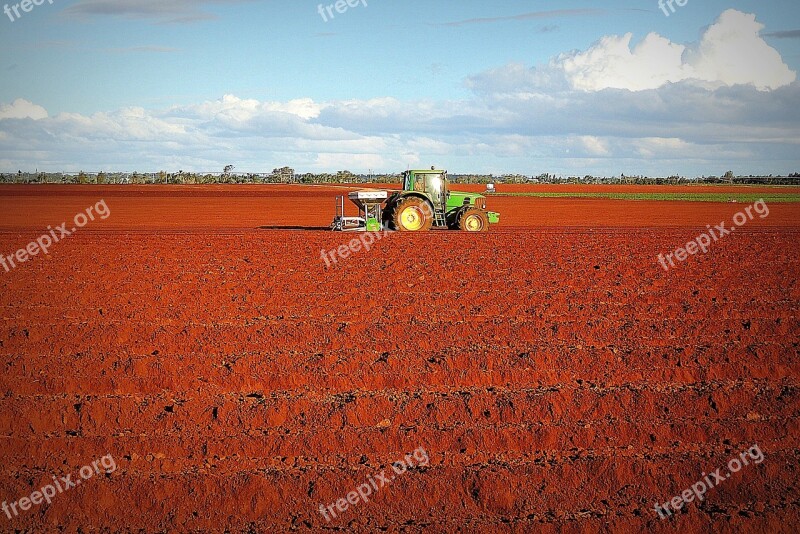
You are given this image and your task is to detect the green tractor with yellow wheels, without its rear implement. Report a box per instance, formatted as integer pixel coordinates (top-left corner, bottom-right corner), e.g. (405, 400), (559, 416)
(383, 168), (500, 232)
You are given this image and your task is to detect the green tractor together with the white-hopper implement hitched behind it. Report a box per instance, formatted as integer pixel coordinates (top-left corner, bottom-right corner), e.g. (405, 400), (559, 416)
(331, 167), (500, 232)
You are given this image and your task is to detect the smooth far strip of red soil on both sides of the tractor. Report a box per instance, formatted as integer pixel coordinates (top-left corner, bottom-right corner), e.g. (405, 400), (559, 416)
(0, 185), (800, 230)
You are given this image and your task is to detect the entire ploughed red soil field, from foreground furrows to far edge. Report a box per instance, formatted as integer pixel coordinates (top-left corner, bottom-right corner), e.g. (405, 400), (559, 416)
(0, 186), (800, 533)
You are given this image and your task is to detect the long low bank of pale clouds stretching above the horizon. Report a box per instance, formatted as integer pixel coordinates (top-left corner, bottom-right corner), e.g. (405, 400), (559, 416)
(0, 82), (800, 175)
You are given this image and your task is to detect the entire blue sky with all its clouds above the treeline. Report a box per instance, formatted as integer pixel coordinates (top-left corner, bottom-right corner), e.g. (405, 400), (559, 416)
(0, 0), (800, 175)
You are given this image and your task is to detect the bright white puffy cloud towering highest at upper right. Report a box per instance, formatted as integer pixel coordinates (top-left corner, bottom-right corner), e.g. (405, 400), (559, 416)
(551, 9), (797, 91)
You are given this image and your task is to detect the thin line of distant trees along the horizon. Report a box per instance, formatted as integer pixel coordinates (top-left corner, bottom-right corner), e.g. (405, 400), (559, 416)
(0, 170), (800, 185)
